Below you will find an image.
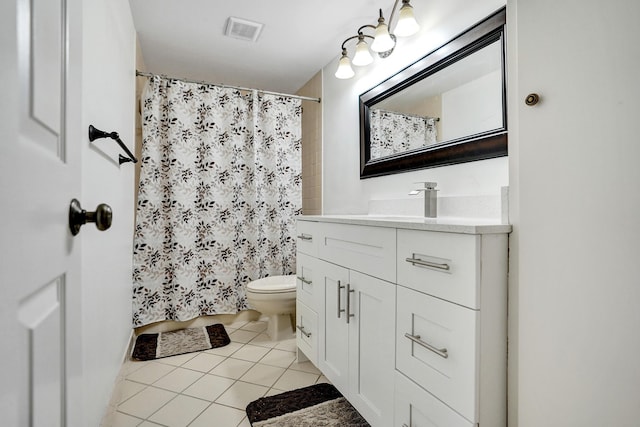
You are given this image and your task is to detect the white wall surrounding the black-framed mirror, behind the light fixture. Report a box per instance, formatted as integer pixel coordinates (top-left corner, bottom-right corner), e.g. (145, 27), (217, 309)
(322, 0), (508, 214)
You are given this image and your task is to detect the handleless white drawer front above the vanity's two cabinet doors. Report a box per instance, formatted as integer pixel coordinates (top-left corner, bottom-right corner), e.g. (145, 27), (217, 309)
(318, 223), (396, 282)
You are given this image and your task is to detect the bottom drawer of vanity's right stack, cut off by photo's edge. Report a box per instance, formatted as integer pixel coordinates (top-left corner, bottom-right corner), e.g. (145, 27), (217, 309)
(394, 372), (473, 427)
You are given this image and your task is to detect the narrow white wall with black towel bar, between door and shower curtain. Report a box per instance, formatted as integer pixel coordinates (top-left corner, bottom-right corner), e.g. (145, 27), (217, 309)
(80, 0), (135, 426)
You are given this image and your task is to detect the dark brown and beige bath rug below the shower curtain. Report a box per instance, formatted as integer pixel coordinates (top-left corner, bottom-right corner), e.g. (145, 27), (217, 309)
(131, 323), (231, 360)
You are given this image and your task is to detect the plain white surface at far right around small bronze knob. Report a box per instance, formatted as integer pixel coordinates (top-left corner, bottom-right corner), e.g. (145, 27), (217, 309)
(507, 0), (640, 427)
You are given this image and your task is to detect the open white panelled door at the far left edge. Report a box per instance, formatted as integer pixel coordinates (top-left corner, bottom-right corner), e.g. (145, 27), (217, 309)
(0, 0), (86, 426)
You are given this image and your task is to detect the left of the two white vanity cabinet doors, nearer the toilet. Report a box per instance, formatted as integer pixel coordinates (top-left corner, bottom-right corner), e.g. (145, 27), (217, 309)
(315, 260), (349, 396)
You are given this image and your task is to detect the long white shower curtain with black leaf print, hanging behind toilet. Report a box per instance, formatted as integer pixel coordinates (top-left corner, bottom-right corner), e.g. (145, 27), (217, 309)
(133, 76), (302, 327)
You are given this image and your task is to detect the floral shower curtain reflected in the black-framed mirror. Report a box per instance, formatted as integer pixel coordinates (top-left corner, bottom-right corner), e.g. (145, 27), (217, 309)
(370, 108), (437, 159)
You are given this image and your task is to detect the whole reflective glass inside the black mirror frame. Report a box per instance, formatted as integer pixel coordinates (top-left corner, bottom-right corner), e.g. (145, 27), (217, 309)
(369, 41), (504, 159)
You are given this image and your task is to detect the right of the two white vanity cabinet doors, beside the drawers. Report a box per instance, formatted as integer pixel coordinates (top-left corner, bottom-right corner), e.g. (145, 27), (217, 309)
(347, 271), (395, 426)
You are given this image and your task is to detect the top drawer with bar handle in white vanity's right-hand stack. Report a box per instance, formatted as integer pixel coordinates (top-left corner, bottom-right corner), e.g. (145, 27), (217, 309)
(397, 230), (481, 309)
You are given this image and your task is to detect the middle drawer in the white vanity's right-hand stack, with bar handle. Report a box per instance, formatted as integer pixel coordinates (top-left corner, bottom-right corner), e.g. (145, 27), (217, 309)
(396, 286), (478, 421)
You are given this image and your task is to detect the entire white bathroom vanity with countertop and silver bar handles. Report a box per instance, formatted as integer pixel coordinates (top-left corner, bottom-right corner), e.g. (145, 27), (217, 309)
(296, 216), (511, 427)
